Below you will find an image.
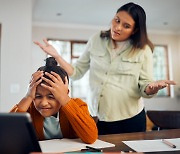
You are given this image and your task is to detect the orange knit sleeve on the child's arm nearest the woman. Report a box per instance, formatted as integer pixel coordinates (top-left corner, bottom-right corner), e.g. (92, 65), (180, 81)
(61, 98), (98, 144)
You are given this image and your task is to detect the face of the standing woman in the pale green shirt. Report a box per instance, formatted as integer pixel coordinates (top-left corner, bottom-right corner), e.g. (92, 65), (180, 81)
(111, 11), (135, 41)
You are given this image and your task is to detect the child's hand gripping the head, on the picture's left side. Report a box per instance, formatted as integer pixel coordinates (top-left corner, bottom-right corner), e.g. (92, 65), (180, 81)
(26, 71), (43, 100)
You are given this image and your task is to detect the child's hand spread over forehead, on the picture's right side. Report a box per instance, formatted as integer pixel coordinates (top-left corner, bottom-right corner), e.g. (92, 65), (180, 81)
(41, 72), (70, 106)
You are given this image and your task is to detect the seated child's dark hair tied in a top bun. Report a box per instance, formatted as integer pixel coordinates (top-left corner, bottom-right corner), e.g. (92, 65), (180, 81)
(38, 57), (69, 83)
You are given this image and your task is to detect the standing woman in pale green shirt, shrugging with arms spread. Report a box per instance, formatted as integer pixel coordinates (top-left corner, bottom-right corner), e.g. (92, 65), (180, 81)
(35, 3), (175, 134)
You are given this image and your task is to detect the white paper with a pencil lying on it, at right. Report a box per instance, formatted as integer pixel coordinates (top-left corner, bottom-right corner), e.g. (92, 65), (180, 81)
(122, 138), (180, 152)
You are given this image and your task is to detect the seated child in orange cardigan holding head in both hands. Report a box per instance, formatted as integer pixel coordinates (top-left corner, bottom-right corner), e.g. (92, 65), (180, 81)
(11, 57), (98, 143)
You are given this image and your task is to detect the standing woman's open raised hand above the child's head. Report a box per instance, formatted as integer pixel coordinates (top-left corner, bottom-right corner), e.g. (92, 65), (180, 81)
(34, 39), (59, 58)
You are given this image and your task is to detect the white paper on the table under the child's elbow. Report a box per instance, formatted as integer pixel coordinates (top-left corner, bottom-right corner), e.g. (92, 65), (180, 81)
(39, 138), (115, 152)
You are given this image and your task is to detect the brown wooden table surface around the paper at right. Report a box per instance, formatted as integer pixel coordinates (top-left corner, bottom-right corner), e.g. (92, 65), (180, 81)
(99, 129), (180, 154)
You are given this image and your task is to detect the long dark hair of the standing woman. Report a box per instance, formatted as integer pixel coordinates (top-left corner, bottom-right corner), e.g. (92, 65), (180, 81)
(100, 2), (154, 51)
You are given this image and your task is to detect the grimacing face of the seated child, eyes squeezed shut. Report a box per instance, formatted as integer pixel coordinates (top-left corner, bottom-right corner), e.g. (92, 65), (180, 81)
(34, 85), (61, 117)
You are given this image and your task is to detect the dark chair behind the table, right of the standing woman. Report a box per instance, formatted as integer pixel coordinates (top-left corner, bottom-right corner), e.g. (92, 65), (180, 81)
(146, 110), (180, 130)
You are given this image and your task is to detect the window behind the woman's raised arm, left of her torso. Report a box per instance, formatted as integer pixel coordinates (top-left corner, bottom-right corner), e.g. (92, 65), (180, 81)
(48, 39), (89, 102)
